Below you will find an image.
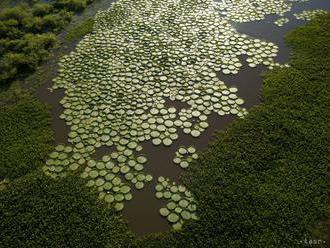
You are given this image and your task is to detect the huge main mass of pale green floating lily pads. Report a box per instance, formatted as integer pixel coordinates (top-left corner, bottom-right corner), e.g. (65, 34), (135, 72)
(44, 0), (289, 210)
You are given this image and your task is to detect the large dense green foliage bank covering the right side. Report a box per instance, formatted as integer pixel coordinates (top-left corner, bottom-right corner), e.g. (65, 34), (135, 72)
(138, 15), (330, 248)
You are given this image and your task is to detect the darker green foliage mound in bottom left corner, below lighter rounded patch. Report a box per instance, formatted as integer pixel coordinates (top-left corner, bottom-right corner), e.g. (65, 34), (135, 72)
(0, 171), (131, 248)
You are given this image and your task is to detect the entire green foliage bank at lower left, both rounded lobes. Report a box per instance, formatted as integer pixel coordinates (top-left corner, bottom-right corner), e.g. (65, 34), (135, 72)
(0, 94), (132, 248)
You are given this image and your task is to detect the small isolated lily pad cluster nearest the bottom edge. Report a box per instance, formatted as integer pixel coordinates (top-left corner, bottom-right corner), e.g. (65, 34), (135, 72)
(156, 177), (198, 230)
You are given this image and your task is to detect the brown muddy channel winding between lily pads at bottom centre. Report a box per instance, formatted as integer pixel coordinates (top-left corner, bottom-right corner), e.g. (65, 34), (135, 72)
(123, 112), (235, 235)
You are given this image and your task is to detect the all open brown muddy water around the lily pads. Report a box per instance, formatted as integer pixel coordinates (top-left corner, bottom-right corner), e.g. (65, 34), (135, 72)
(37, 0), (330, 235)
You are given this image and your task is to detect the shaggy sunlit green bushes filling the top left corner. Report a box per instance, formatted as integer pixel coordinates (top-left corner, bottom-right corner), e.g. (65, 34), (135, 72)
(0, 0), (90, 88)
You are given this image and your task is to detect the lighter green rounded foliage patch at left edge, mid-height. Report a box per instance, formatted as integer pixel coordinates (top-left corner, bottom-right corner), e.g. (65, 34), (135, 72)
(0, 96), (52, 180)
